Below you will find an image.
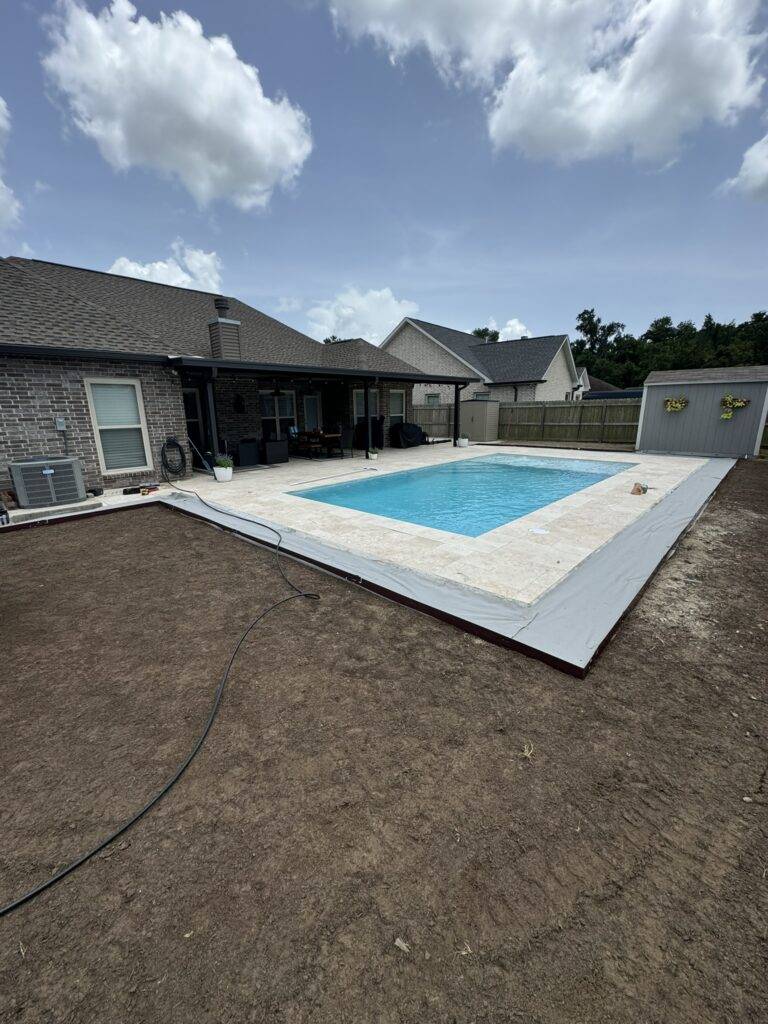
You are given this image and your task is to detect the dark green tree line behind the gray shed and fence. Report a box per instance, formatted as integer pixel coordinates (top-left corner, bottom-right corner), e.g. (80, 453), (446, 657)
(472, 309), (768, 387)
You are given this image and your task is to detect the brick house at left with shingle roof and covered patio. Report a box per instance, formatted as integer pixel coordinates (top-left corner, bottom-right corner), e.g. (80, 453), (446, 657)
(0, 257), (475, 489)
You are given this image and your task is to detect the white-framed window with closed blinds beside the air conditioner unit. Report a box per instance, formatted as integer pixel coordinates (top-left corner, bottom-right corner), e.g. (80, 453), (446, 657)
(85, 377), (153, 473)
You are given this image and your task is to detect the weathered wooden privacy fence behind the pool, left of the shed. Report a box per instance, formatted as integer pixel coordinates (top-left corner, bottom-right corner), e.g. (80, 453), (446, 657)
(414, 398), (640, 444)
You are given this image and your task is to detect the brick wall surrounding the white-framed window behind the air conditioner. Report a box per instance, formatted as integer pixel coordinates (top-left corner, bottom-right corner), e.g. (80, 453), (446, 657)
(0, 357), (190, 489)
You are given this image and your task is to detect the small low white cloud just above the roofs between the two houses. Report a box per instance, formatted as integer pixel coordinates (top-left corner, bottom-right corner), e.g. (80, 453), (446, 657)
(306, 288), (419, 345)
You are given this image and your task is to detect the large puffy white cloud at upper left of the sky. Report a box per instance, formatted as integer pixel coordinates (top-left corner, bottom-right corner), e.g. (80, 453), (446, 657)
(43, 0), (312, 210)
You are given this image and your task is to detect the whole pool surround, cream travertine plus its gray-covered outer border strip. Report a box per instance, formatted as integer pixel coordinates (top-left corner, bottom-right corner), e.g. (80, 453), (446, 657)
(9, 444), (734, 677)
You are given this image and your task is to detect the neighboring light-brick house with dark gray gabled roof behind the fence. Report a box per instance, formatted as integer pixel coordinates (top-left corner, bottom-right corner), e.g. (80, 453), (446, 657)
(381, 316), (582, 406)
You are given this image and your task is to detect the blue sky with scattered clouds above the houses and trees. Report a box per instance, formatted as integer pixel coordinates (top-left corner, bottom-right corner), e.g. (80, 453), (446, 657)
(0, 0), (768, 340)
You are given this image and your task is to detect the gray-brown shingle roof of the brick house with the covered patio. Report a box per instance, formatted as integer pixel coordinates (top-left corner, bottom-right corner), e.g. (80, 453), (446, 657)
(0, 257), (460, 374)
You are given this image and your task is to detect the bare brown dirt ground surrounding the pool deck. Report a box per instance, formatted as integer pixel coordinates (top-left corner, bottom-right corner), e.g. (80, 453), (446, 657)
(0, 463), (768, 1024)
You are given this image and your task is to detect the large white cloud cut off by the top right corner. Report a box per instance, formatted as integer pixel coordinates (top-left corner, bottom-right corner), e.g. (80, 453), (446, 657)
(332, 0), (765, 163)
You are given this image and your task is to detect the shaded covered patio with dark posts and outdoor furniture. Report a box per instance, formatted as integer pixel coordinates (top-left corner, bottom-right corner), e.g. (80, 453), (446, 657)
(173, 343), (472, 468)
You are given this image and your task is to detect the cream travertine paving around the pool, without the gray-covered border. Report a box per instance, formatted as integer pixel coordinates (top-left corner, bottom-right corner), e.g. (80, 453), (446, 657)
(180, 444), (708, 604)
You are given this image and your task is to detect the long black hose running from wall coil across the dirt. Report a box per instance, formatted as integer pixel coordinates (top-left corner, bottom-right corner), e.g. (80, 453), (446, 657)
(0, 438), (319, 918)
